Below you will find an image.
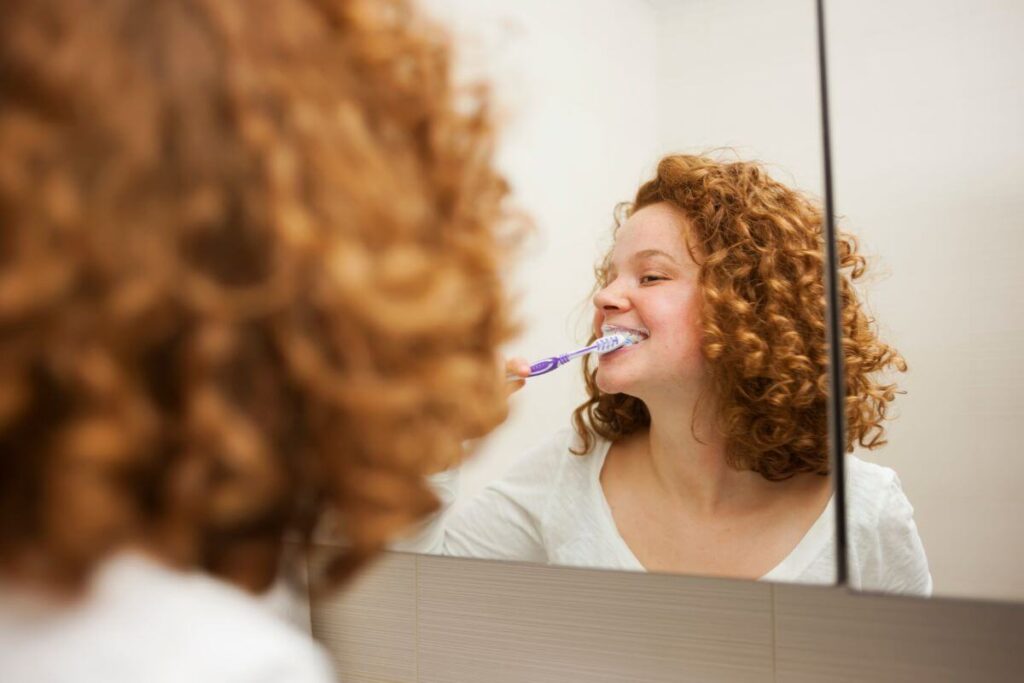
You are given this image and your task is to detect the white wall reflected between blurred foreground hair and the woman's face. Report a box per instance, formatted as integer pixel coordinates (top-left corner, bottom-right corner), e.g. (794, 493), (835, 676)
(423, 0), (658, 505)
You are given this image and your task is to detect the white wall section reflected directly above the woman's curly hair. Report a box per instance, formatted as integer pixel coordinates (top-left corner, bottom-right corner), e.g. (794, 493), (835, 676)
(656, 0), (824, 198)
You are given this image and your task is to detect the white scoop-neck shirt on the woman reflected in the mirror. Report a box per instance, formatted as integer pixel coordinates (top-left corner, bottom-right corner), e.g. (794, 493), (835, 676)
(397, 429), (932, 595)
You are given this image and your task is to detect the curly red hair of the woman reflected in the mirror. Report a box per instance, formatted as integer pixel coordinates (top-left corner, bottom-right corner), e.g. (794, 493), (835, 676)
(572, 155), (906, 481)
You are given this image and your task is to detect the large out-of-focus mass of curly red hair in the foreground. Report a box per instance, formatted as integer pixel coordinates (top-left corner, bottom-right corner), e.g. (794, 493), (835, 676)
(0, 0), (517, 590)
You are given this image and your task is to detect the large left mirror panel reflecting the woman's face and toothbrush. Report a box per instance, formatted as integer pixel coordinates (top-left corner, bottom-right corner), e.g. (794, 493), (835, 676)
(399, 0), (836, 584)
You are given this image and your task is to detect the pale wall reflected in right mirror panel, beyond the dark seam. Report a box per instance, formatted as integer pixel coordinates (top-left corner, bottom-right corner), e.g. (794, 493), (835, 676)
(826, 0), (1024, 600)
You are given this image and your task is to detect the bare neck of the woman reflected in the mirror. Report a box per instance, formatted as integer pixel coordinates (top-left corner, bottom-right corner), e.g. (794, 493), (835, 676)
(644, 387), (767, 515)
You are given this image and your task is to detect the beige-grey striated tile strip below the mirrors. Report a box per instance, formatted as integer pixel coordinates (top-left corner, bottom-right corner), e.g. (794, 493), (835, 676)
(312, 553), (1024, 683)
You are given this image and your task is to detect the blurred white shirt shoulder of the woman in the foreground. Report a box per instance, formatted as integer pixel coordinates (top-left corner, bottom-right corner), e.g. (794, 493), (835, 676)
(0, 552), (335, 683)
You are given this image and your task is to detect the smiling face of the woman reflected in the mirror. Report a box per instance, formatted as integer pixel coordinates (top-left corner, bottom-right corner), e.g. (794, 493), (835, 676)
(594, 203), (707, 401)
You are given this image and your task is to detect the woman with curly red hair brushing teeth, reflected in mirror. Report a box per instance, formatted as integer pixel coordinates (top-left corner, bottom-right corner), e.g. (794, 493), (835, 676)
(419, 155), (931, 594)
